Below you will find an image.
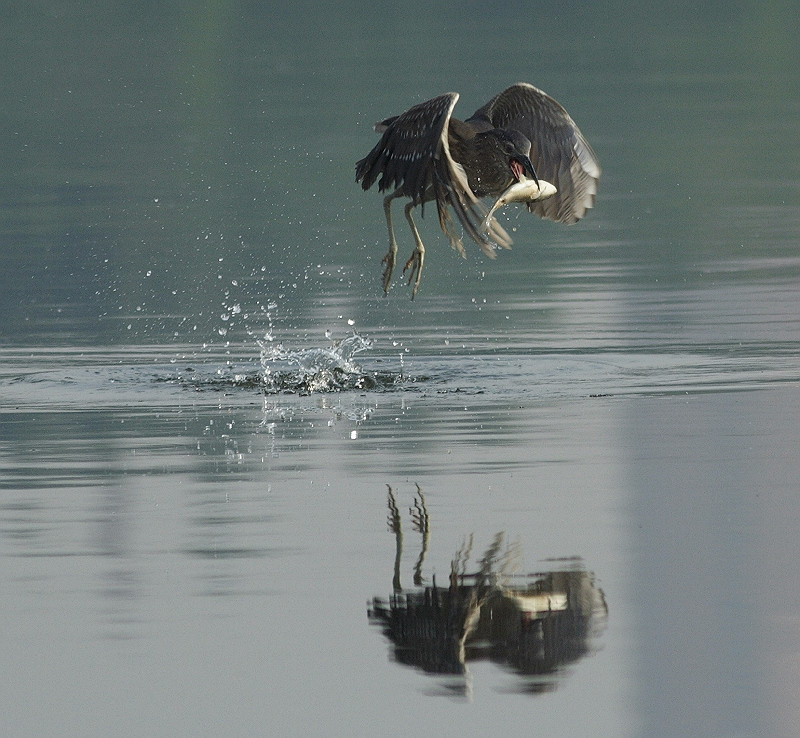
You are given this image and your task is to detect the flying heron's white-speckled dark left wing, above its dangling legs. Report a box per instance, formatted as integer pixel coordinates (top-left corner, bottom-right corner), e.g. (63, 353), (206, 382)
(356, 92), (511, 257)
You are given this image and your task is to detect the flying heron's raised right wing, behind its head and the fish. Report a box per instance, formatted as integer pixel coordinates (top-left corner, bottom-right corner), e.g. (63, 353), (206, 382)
(469, 82), (600, 223)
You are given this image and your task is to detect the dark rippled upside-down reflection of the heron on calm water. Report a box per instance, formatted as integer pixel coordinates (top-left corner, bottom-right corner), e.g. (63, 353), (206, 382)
(368, 485), (608, 697)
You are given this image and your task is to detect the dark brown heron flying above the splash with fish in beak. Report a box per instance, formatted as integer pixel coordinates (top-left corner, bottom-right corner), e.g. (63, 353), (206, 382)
(356, 82), (600, 299)
